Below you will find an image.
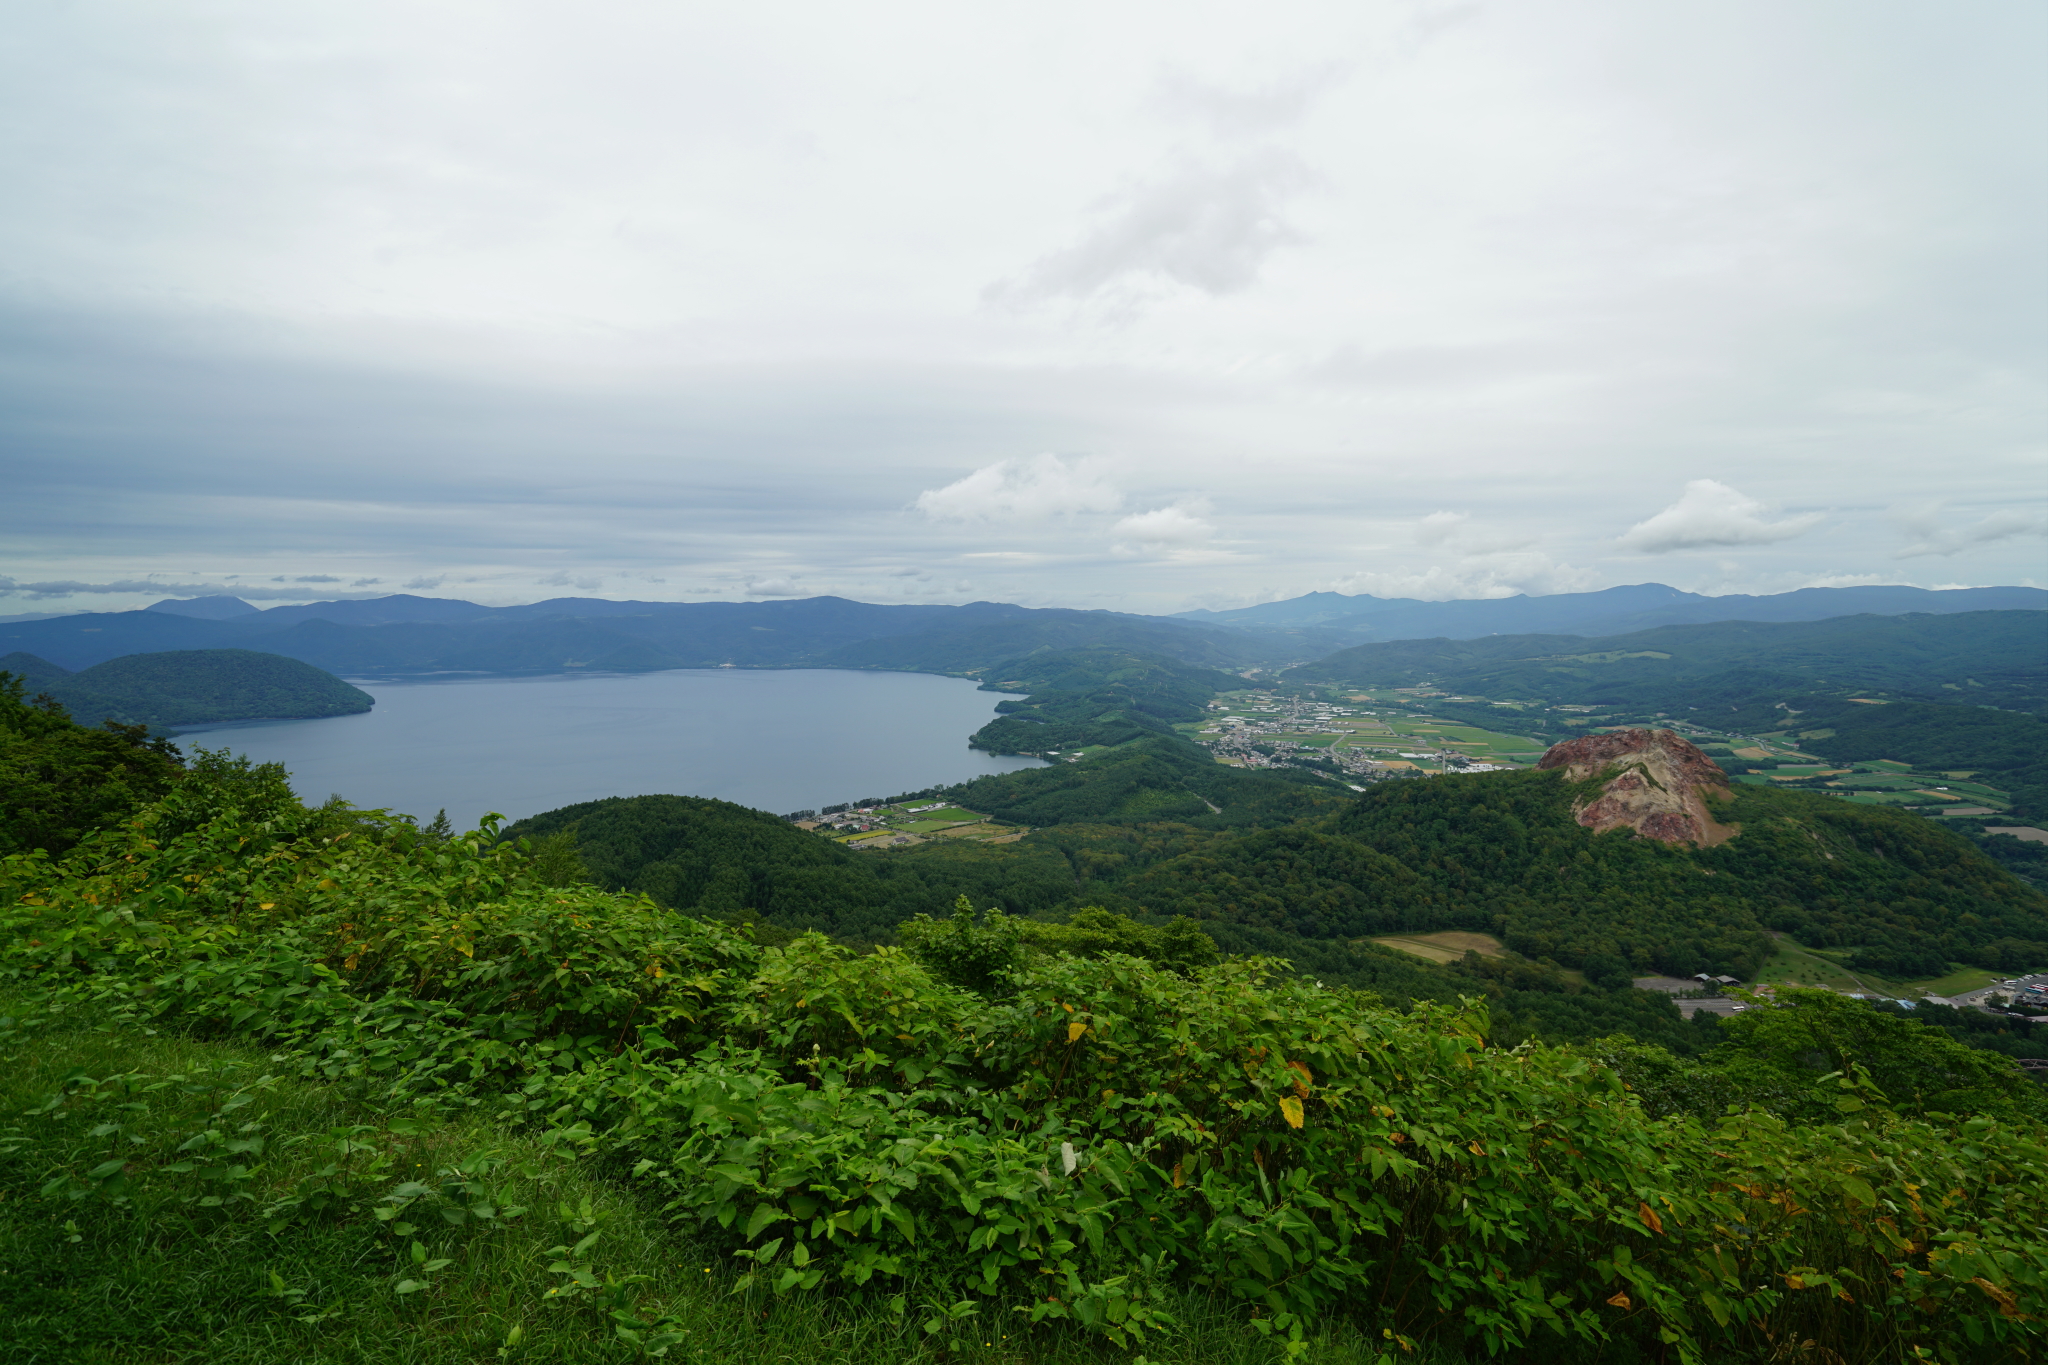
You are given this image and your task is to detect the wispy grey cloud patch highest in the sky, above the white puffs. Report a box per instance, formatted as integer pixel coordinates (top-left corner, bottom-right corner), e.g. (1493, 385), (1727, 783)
(987, 147), (1309, 303)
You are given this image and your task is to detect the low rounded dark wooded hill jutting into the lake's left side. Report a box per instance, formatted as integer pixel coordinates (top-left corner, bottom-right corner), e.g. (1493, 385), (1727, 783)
(49, 649), (373, 724)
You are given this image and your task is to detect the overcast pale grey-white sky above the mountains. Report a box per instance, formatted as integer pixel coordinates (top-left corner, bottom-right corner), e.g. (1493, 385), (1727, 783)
(0, 0), (2048, 614)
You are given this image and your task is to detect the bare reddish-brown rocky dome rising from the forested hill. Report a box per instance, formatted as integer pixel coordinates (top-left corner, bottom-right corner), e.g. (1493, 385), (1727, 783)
(1536, 731), (1741, 847)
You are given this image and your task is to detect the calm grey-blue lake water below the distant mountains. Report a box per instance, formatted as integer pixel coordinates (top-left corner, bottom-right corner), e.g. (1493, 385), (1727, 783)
(180, 669), (1038, 829)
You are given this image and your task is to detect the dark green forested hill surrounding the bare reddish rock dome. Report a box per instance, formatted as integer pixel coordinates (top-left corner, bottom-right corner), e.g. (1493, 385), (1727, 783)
(1104, 772), (2048, 978)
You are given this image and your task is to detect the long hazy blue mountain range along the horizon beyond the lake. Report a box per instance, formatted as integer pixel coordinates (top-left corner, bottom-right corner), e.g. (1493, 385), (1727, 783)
(0, 583), (2048, 675)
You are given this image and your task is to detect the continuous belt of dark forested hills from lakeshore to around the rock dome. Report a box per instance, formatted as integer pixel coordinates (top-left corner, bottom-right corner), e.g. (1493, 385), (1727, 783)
(514, 741), (2048, 995)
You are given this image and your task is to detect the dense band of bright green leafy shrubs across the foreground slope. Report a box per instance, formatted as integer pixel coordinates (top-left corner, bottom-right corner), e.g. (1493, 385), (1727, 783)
(0, 757), (2048, 1361)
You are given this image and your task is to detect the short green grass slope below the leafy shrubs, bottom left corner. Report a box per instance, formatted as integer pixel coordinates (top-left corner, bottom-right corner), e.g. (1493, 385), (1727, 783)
(0, 999), (1464, 1365)
